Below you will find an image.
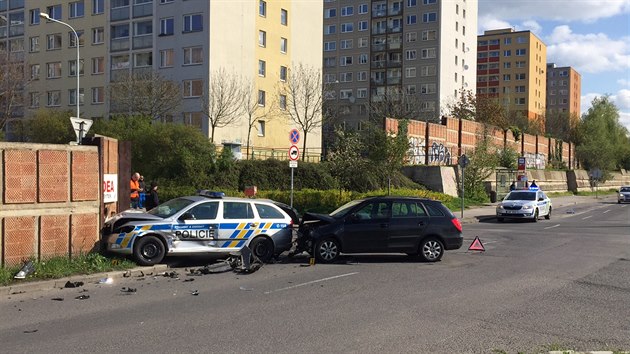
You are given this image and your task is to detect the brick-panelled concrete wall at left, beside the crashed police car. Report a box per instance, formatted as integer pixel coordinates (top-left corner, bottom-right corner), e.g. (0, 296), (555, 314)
(0, 143), (102, 265)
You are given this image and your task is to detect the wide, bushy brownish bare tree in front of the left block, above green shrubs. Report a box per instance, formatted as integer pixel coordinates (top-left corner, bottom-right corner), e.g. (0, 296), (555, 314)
(109, 70), (180, 119)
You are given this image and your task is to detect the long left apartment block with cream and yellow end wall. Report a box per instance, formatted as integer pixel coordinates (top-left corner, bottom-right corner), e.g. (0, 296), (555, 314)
(0, 0), (323, 155)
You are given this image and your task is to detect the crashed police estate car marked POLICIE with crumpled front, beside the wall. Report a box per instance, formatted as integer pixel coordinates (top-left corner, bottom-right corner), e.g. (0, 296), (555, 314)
(102, 191), (297, 265)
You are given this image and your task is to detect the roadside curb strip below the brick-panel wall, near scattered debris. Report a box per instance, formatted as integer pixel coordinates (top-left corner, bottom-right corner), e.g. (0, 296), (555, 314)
(0, 264), (168, 295)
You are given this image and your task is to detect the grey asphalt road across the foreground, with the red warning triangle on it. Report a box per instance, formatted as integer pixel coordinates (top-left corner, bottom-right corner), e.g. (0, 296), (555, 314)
(0, 198), (630, 353)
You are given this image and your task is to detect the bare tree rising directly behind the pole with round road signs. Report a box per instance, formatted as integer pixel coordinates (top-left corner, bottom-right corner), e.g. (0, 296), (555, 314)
(278, 63), (327, 160)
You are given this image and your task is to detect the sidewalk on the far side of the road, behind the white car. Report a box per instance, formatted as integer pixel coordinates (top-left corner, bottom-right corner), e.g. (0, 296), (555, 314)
(460, 195), (615, 224)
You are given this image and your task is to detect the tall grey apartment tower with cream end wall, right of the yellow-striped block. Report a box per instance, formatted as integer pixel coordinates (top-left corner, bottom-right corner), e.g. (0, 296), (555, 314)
(323, 0), (477, 130)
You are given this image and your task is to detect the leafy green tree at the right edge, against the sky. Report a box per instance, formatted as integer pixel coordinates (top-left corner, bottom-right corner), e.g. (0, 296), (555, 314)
(576, 96), (630, 175)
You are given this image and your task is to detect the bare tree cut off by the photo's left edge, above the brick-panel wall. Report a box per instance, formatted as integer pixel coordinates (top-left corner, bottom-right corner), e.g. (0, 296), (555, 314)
(0, 48), (30, 131)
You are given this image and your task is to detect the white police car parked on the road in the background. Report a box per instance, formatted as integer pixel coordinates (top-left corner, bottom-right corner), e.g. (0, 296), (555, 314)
(497, 189), (552, 222)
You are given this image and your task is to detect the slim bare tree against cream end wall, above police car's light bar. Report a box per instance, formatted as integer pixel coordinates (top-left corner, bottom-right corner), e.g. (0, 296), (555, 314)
(201, 68), (243, 142)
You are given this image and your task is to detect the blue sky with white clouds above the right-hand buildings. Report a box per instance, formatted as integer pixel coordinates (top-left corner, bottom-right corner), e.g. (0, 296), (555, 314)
(478, 0), (630, 130)
